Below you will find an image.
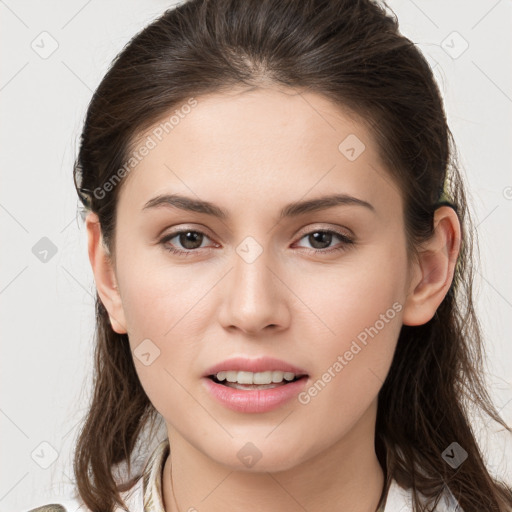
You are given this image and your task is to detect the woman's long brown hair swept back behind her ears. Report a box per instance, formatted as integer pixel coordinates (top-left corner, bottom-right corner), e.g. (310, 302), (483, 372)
(74, 0), (512, 512)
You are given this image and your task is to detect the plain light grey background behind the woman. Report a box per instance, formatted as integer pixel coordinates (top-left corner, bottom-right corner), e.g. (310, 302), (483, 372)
(0, 0), (512, 512)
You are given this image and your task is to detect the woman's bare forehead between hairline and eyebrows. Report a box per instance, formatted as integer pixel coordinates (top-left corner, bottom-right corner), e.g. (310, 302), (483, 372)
(119, 88), (399, 216)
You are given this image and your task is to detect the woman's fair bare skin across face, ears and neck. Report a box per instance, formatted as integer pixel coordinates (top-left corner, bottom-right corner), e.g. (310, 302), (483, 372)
(86, 87), (460, 512)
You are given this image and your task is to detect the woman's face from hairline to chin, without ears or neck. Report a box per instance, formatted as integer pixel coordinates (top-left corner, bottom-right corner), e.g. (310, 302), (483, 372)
(102, 88), (409, 471)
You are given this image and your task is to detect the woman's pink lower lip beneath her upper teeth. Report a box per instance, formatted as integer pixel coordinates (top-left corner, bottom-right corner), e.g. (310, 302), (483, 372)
(203, 376), (308, 413)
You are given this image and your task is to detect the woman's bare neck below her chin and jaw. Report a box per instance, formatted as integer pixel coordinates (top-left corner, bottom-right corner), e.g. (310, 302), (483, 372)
(162, 402), (384, 512)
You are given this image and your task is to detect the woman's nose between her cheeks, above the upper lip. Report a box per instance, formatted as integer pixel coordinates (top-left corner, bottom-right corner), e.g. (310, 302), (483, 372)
(218, 243), (290, 335)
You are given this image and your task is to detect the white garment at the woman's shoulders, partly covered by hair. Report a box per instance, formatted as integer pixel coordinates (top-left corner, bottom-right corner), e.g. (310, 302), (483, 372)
(28, 440), (464, 512)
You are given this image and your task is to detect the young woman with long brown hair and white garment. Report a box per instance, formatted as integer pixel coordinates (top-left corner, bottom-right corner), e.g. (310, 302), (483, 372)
(27, 0), (512, 512)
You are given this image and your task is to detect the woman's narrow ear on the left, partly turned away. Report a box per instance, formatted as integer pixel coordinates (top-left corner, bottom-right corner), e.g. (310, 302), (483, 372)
(85, 212), (127, 334)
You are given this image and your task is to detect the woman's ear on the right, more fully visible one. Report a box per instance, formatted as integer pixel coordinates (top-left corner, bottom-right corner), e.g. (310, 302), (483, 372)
(402, 206), (461, 325)
